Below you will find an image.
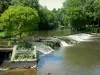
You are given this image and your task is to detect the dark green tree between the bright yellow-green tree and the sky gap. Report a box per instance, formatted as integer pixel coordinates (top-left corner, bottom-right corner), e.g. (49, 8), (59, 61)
(38, 7), (58, 30)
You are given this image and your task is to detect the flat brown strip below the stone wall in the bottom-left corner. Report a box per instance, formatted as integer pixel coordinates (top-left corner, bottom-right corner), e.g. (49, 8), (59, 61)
(0, 69), (37, 75)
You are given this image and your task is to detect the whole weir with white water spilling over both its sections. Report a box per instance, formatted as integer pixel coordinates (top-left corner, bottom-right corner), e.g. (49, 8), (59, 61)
(34, 33), (91, 54)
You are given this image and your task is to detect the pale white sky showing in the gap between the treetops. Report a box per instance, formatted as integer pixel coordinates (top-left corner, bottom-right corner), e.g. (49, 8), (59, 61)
(39, 0), (65, 10)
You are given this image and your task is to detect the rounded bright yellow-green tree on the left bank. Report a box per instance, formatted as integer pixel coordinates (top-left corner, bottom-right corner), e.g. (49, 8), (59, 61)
(0, 6), (39, 37)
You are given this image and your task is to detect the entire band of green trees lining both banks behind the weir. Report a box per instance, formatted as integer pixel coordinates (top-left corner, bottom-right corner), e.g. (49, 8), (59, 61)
(0, 0), (100, 38)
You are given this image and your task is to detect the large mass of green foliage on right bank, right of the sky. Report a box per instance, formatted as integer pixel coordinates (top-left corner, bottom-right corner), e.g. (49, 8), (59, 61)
(58, 0), (100, 29)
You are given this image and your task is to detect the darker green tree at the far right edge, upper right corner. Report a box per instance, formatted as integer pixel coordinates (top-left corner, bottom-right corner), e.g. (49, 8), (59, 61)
(84, 0), (100, 27)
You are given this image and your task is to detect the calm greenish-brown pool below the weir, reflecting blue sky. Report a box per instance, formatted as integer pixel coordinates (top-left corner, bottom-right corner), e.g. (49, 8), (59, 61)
(37, 37), (100, 75)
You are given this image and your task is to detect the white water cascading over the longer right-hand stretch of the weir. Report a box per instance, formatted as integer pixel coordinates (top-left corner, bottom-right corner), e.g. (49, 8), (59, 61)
(42, 33), (91, 47)
